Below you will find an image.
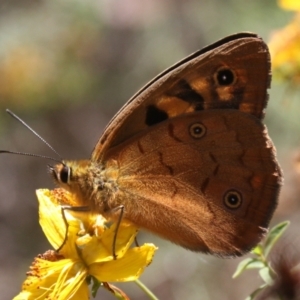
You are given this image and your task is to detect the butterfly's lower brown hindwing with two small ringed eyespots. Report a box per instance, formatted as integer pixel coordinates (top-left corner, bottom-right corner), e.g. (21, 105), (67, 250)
(104, 110), (281, 256)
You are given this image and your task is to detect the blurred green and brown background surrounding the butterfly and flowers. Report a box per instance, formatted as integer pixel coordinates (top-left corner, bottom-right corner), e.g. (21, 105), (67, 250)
(0, 0), (300, 300)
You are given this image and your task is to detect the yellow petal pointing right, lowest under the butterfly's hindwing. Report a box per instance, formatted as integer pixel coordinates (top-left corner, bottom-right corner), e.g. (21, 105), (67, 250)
(89, 244), (157, 282)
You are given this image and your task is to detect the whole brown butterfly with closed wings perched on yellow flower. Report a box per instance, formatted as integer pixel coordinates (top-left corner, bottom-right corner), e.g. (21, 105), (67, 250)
(51, 33), (282, 257)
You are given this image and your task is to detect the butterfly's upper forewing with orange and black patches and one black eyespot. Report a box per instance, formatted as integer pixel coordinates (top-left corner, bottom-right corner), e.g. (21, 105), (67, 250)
(92, 33), (270, 161)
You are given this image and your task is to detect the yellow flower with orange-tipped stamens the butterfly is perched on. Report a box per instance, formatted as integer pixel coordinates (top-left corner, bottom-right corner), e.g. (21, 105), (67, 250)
(14, 189), (156, 300)
